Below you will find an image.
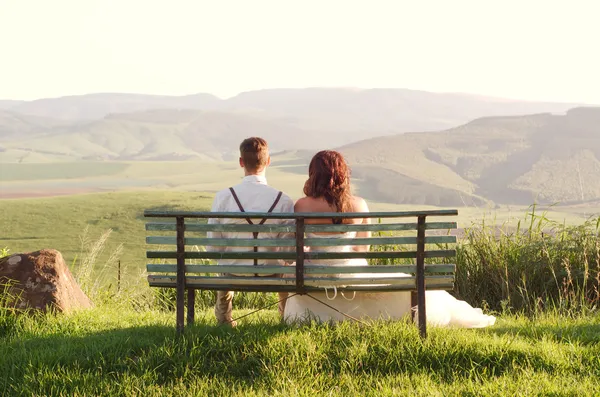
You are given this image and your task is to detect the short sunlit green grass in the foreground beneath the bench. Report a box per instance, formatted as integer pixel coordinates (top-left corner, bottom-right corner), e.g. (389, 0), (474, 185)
(0, 304), (600, 396)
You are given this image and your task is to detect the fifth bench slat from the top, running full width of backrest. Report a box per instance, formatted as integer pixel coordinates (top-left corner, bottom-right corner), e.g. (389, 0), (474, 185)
(146, 264), (456, 274)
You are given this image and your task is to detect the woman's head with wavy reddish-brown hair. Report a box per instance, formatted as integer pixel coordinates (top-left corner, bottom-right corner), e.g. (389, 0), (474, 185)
(304, 150), (351, 212)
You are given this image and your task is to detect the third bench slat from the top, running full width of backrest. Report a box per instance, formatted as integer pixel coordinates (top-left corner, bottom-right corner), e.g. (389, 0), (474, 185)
(146, 236), (456, 247)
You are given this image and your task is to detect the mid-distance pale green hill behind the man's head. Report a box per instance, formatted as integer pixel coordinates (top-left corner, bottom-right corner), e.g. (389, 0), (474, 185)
(0, 109), (343, 162)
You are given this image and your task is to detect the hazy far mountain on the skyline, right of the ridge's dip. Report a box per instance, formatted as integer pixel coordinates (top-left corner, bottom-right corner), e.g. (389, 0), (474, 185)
(225, 88), (578, 134)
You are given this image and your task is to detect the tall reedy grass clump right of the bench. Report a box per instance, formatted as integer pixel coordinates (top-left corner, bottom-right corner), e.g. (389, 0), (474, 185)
(456, 206), (600, 314)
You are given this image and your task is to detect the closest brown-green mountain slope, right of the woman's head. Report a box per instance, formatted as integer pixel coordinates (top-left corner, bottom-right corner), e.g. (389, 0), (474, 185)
(339, 107), (600, 205)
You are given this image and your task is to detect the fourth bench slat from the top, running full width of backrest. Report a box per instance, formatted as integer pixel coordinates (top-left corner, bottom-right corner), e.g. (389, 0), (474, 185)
(146, 250), (456, 260)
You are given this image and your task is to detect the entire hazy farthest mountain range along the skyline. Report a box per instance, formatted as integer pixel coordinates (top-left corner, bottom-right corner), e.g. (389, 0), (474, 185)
(0, 88), (578, 135)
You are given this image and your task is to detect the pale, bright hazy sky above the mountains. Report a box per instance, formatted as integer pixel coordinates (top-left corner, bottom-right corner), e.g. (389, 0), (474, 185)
(0, 0), (600, 104)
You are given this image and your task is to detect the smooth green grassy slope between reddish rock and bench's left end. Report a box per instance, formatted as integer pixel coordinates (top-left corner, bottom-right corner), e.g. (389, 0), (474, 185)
(0, 191), (212, 271)
